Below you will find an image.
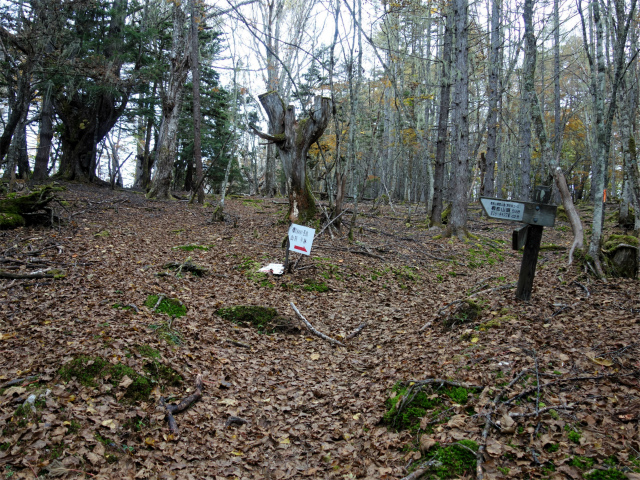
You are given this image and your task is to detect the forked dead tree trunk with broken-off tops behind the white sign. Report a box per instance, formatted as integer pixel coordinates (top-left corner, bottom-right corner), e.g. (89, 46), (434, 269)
(254, 92), (331, 224)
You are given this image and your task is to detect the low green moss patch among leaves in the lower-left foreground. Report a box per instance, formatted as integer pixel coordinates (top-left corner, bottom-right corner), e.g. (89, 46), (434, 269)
(58, 356), (182, 403)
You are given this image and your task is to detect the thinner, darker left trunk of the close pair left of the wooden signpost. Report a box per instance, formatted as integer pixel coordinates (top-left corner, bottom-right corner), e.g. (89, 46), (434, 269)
(431, 6), (454, 225)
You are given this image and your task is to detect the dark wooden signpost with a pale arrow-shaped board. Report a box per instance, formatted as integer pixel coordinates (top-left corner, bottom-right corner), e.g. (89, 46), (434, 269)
(480, 186), (557, 302)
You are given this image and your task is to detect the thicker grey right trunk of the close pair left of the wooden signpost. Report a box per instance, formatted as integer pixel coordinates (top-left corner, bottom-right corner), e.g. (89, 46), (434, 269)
(447, 0), (469, 239)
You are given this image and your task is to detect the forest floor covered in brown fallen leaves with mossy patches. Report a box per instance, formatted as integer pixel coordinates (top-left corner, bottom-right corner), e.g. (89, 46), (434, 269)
(0, 184), (640, 480)
